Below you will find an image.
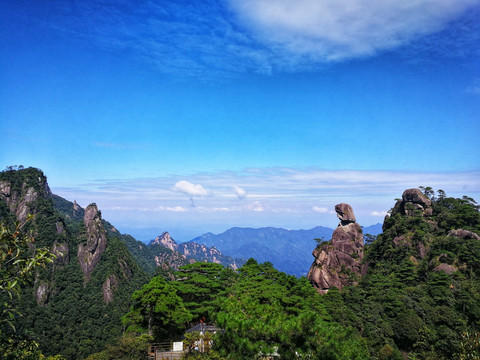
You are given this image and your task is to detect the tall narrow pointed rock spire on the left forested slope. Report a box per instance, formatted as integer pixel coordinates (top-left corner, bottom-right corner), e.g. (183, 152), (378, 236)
(78, 204), (107, 282)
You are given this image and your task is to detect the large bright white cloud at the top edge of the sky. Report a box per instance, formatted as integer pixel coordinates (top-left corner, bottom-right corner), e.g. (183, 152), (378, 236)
(230, 0), (479, 60)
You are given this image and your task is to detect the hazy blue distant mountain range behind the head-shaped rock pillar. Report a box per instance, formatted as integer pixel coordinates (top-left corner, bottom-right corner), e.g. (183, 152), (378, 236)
(189, 224), (382, 276)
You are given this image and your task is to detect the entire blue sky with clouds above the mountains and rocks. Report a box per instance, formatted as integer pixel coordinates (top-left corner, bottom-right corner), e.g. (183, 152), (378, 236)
(0, 0), (480, 240)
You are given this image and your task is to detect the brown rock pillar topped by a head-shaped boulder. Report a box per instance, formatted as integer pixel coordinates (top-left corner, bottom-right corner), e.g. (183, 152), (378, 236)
(307, 203), (364, 294)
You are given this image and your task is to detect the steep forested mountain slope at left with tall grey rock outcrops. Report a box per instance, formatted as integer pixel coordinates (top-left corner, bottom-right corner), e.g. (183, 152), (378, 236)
(0, 168), (148, 359)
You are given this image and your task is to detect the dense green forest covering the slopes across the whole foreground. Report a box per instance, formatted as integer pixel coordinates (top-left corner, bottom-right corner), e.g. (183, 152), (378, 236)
(0, 168), (480, 360)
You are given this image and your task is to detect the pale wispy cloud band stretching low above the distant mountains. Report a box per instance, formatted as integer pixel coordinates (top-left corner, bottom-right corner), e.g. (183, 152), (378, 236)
(52, 168), (480, 230)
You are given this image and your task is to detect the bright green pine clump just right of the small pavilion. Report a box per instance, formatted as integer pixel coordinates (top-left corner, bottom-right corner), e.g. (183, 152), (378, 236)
(215, 259), (368, 359)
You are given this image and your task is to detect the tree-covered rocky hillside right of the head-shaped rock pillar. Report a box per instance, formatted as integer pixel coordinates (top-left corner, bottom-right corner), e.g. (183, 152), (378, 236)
(318, 188), (480, 360)
